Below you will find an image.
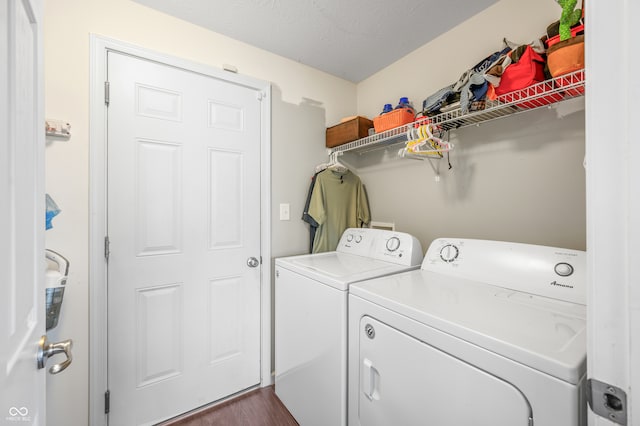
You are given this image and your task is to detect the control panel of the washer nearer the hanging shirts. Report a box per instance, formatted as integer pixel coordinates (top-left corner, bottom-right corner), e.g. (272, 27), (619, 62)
(336, 228), (422, 266)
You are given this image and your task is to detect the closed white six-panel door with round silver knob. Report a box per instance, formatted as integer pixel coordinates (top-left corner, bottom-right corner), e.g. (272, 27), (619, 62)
(107, 52), (261, 425)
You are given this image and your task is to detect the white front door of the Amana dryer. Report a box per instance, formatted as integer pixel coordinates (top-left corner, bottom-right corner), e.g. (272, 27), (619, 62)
(358, 316), (532, 426)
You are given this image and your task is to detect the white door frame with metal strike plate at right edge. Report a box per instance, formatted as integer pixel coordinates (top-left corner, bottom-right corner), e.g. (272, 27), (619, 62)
(585, 0), (640, 426)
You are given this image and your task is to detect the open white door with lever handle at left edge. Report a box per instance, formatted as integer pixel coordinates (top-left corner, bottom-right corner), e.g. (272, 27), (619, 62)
(0, 0), (45, 425)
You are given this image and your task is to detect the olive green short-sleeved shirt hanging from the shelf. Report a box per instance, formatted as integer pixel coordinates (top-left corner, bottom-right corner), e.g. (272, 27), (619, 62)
(308, 169), (371, 253)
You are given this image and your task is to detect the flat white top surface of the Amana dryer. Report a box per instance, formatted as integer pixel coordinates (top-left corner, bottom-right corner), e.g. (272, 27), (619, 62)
(350, 270), (586, 384)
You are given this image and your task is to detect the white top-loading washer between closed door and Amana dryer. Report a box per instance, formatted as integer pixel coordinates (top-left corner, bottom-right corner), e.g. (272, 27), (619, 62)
(275, 228), (422, 426)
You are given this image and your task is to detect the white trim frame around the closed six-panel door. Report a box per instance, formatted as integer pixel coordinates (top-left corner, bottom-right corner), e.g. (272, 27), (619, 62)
(89, 34), (272, 425)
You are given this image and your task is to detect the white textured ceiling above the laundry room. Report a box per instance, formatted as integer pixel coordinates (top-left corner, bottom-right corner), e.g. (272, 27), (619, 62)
(134, 0), (497, 82)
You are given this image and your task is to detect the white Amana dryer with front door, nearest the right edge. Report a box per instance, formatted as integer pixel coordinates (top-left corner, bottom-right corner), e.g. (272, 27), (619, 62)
(349, 239), (586, 426)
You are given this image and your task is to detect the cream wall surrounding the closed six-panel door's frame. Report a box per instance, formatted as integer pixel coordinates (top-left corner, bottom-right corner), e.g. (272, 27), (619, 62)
(44, 0), (356, 426)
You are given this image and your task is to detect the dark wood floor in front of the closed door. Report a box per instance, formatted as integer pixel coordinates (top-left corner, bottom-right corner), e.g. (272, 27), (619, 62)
(159, 386), (298, 426)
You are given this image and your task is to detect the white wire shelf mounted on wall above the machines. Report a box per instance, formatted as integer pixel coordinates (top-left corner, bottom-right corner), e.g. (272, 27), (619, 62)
(331, 69), (584, 154)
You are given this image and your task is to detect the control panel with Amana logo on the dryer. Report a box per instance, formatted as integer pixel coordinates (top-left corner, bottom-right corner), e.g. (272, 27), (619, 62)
(422, 238), (586, 305)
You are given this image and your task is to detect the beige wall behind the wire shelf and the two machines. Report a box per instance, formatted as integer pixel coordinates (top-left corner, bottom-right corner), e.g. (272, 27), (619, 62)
(356, 0), (586, 250)
